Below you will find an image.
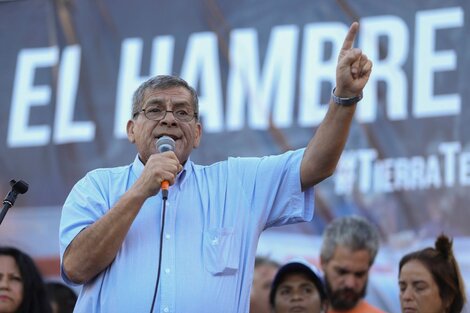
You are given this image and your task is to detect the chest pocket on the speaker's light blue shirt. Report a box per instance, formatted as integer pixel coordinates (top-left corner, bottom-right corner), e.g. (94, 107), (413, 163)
(204, 227), (240, 276)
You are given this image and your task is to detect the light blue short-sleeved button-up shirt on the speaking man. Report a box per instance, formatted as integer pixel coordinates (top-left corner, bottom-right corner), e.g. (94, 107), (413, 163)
(60, 149), (314, 313)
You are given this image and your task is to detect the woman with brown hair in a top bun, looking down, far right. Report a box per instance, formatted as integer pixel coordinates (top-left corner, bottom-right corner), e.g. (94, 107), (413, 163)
(398, 235), (466, 313)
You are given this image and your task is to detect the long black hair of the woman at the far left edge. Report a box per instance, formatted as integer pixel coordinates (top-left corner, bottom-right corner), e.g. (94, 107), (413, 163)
(0, 247), (52, 313)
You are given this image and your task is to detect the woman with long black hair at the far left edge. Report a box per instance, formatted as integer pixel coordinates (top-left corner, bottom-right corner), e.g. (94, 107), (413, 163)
(0, 247), (51, 313)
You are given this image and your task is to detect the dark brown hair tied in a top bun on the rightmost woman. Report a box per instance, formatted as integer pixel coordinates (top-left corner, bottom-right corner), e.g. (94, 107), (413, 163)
(399, 234), (466, 313)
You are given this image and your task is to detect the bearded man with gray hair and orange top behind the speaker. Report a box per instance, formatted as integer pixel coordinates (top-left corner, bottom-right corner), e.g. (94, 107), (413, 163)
(320, 216), (383, 313)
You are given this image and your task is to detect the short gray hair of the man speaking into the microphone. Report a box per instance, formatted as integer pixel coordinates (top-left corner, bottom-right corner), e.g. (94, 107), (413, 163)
(132, 75), (199, 119)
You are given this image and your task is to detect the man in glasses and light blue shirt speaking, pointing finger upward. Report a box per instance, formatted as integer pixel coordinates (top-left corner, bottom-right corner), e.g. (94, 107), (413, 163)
(60, 23), (372, 313)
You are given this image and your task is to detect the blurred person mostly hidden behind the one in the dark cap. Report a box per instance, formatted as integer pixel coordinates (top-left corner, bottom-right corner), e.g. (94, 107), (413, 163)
(250, 256), (279, 313)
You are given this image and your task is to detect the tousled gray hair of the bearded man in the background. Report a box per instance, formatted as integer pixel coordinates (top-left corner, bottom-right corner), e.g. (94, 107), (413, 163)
(320, 216), (379, 265)
